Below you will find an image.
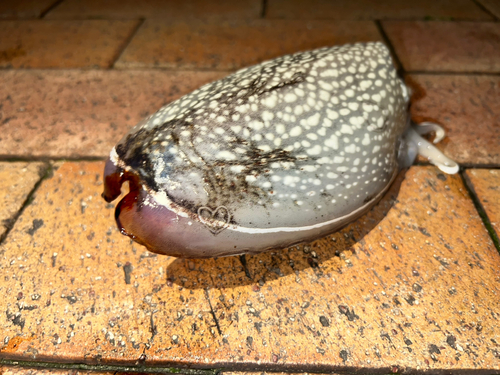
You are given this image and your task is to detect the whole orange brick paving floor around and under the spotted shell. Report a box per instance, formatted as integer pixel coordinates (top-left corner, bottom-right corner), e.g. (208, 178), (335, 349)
(0, 0), (500, 375)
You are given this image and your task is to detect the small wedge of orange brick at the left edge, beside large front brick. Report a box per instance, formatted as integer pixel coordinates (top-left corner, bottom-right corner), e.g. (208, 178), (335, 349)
(0, 162), (47, 239)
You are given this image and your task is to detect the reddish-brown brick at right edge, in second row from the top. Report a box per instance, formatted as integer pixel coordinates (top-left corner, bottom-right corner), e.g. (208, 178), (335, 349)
(382, 21), (500, 73)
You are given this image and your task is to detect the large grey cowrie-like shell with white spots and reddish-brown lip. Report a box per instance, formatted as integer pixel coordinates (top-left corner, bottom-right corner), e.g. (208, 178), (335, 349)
(103, 42), (458, 258)
